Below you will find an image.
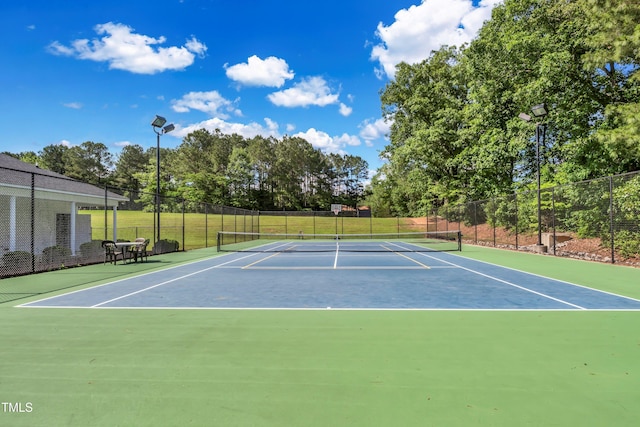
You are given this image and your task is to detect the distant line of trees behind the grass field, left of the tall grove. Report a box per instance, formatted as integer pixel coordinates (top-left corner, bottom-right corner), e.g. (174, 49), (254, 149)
(2, 129), (369, 210)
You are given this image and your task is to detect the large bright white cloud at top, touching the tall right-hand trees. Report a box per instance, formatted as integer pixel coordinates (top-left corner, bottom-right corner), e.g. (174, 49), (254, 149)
(371, 0), (502, 78)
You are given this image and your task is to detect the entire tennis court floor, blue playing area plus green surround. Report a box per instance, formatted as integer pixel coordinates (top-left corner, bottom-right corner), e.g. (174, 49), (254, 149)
(0, 236), (640, 427)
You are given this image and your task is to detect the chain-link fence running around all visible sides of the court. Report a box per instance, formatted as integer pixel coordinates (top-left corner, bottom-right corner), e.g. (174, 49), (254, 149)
(0, 168), (640, 291)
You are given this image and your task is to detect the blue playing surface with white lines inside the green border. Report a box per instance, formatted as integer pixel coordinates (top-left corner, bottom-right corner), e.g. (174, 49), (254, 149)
(17, 248), (640, 310)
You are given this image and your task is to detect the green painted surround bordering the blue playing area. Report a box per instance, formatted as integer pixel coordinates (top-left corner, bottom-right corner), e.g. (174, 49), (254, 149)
(0, 246), (640, 426)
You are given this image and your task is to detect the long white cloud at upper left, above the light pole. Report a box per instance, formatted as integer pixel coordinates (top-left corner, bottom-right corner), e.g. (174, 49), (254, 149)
(48, 22), (207, 74)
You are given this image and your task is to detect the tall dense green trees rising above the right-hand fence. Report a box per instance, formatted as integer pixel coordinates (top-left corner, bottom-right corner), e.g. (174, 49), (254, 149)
(370, 0), (640, 215)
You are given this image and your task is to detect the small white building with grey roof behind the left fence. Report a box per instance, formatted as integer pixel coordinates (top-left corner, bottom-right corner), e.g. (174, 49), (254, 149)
(0, 154), (128, 257)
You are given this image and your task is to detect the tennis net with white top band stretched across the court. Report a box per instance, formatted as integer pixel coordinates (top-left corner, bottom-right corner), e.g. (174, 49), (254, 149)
(217, 230), (462, 252)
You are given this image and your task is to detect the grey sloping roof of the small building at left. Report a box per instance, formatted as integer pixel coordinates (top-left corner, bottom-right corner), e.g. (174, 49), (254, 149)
(0, 153), (128, 206)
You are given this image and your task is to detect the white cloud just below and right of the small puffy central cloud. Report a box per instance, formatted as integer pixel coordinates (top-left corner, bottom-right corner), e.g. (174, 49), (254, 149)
(267, 76), (339, 107)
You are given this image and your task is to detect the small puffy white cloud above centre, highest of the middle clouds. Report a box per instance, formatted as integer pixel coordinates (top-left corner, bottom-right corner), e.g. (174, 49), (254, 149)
(225, 55), (294, 87)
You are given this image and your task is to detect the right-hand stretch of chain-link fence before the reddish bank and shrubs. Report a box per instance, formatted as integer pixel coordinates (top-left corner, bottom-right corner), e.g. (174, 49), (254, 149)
(429, 173), (640, 266)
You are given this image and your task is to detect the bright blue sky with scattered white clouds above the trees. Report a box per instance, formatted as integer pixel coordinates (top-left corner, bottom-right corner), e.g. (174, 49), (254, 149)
(0, 0), (499, 174)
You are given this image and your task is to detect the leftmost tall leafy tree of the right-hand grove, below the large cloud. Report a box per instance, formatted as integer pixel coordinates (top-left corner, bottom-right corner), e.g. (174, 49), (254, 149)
(381, 47), (468, 215)
